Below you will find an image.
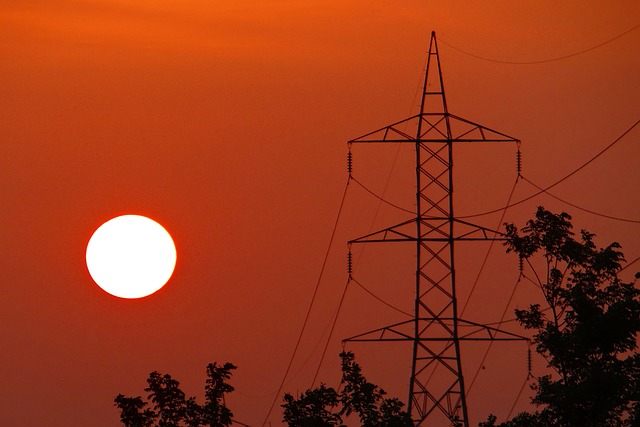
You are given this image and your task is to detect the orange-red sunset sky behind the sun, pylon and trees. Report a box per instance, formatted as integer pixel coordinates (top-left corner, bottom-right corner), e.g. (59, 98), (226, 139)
(0, 0), (640, 427)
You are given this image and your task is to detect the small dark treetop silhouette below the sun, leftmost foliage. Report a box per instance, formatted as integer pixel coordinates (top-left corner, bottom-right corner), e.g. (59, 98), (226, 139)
(114, 363), (236, 427)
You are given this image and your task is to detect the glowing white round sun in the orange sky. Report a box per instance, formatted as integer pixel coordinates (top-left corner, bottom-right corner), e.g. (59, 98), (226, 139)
(86, 215), (176, 299)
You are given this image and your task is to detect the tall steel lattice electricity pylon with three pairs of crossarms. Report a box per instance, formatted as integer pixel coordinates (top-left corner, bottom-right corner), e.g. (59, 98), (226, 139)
(345, 32), (523, 427)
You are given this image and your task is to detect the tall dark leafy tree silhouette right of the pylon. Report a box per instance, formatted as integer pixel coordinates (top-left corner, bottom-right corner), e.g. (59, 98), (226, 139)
(480, 207), (640, 427)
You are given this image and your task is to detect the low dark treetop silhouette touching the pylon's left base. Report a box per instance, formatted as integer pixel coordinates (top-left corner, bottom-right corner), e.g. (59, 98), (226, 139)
(282, 352), (413, 427)
